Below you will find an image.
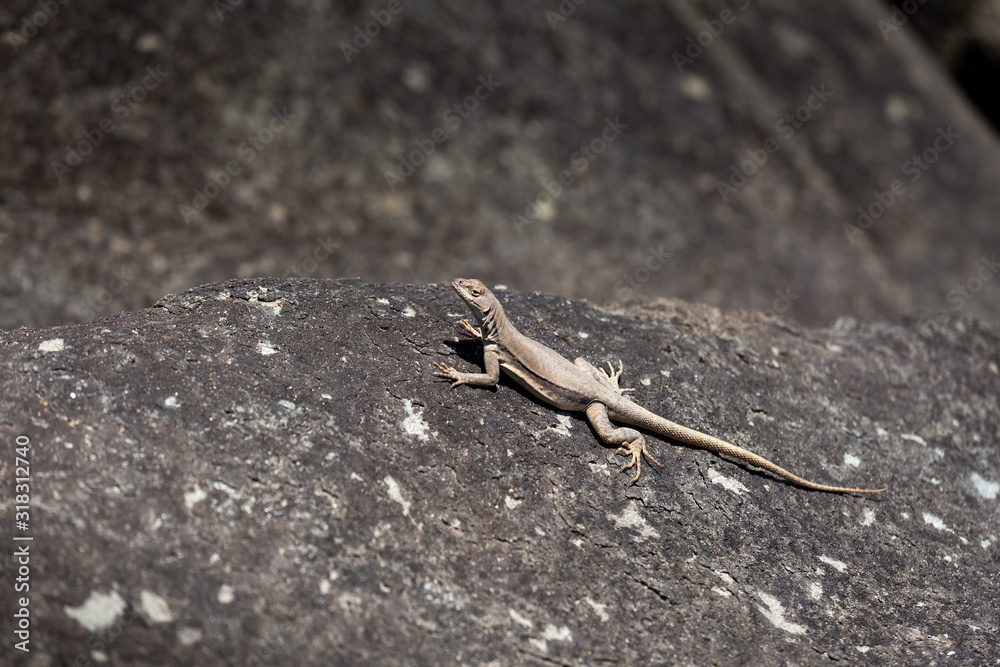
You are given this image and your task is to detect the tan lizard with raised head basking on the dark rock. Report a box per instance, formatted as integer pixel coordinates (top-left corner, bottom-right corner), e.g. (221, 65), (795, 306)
(431, 278), (885, 493)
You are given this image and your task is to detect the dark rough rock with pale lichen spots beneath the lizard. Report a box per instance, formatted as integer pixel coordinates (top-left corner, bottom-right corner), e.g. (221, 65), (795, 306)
(0, 279), (1000, 665)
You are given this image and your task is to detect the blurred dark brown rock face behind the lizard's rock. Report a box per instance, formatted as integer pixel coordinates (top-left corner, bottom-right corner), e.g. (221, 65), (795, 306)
(0, 0), (1000, 328)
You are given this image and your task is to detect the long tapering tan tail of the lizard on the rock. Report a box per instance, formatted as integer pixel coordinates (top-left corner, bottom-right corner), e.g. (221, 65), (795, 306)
(609, 401), (885, 493)
